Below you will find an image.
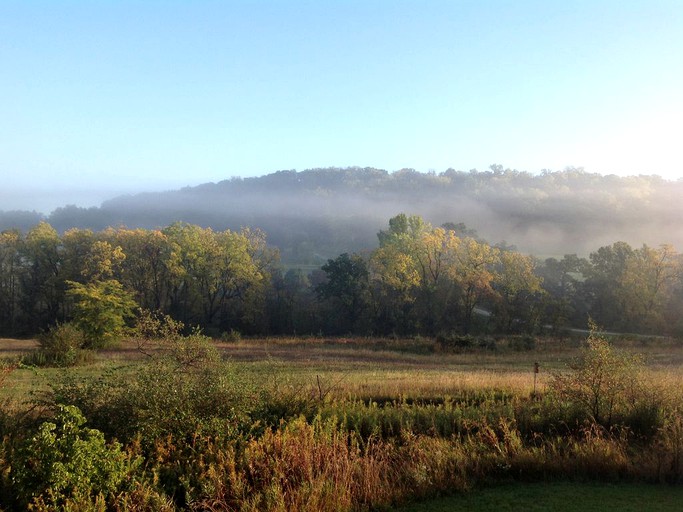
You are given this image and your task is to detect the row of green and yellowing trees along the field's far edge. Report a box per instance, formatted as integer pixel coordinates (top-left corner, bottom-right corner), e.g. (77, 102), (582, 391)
(0, 214), (683, 338)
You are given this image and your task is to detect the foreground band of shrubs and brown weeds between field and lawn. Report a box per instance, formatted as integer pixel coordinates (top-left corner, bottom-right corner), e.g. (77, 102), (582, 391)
(0, 330), (683, 511)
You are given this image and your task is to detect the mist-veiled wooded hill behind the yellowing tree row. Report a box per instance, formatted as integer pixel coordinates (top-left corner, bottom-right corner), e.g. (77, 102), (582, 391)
(0, 166), (683, 264)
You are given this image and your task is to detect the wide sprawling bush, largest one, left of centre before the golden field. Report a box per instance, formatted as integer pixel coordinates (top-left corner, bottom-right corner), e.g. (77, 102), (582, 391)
(52, 333), (263, 445)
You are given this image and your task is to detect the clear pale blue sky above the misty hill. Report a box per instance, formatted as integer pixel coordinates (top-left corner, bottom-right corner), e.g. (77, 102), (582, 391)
(0, 0), (683, 213)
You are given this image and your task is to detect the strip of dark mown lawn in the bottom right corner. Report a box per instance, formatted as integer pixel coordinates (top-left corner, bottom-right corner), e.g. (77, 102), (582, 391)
(396, 483), (683, 512)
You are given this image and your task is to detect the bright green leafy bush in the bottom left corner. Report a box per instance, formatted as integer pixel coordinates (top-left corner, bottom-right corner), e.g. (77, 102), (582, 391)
(10, 406), (138, 509)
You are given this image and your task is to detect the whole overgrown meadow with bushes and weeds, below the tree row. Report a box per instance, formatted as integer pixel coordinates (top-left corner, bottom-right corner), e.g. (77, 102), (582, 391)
(0, 334), (683, 511)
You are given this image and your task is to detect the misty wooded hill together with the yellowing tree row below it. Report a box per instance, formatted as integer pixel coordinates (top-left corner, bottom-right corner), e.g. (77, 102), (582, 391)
(0, 166), (683, 338)
